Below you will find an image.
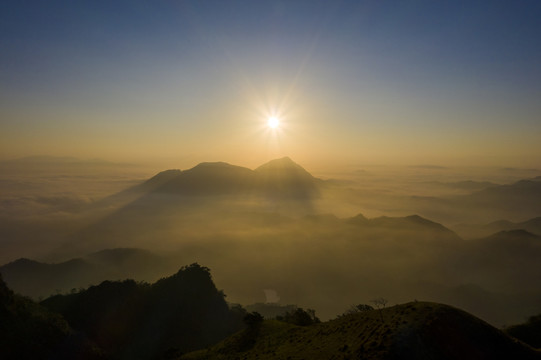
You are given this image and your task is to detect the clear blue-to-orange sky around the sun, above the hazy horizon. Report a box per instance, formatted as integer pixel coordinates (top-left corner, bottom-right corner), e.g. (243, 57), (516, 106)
(0, 0), (541, 167)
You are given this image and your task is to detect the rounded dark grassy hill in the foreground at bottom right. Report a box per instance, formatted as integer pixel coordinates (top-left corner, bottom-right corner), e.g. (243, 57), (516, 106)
(179, 302), (541, 360)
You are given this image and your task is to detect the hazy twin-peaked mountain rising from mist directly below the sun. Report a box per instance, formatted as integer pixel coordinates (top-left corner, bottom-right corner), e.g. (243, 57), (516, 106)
(84, 157), (325, 217)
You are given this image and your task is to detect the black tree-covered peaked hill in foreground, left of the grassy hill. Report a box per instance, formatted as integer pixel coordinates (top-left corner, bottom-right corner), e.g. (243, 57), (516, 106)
(42, 264), (244, 359)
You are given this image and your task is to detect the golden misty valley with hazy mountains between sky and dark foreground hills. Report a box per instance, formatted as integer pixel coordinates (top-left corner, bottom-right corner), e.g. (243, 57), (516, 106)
(0, 158), (541, 326)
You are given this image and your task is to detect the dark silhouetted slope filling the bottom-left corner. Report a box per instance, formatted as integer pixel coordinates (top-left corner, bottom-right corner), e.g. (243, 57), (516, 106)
(0, 276), (102, 360)
